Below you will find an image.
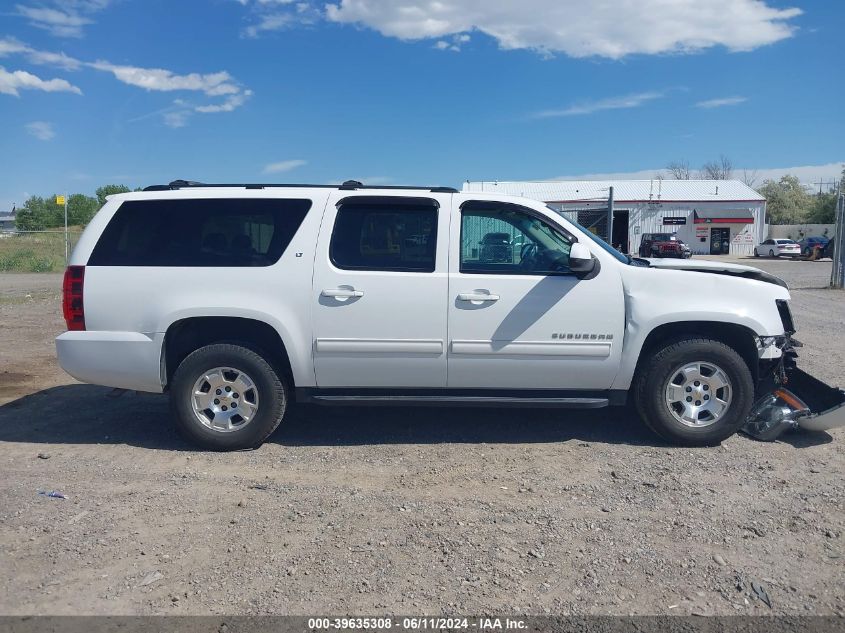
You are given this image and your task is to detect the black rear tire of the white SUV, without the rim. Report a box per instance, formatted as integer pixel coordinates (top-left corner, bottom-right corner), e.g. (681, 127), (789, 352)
(170, 343), (288, 451)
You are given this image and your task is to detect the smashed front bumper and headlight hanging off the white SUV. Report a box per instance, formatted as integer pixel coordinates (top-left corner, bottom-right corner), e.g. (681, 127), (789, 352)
(742, 337), (845, 441)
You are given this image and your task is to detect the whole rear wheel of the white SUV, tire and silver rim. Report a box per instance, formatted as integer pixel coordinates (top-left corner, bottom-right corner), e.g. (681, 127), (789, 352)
(170, 343), (287, 451)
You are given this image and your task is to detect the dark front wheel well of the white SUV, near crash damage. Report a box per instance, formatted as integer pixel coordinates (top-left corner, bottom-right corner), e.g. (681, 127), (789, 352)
(634, 321), (760, 383)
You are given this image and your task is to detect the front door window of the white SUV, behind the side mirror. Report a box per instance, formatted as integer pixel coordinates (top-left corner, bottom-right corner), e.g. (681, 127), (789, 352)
(461, 208), (572, 275)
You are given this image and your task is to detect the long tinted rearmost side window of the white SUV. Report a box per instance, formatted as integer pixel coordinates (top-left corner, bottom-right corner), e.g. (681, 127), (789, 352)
(88, 198), (311, 266)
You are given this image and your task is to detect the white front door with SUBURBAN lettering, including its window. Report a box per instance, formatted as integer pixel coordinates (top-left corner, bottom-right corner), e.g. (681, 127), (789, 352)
(448, 201), (625, 390)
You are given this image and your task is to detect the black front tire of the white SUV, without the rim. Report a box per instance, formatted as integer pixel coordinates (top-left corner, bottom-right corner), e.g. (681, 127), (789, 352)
(634, 338), (754, 446)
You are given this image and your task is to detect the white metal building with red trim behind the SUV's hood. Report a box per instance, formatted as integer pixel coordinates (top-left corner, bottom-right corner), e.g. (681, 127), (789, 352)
(463, 180), (768, 255)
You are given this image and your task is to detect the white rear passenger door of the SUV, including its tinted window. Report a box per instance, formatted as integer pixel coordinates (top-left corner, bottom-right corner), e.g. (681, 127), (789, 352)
(312, 191), (451, 387)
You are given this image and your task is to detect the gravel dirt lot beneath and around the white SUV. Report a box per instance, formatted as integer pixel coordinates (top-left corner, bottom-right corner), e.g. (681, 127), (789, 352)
(0, 260), (845, 615)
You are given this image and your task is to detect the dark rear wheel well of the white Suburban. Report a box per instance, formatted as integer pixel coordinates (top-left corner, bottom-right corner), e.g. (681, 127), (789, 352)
(162, 317), (293, 386)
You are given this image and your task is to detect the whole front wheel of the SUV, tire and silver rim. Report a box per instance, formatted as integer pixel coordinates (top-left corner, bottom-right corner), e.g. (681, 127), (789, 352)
(634, 338), (754, 446)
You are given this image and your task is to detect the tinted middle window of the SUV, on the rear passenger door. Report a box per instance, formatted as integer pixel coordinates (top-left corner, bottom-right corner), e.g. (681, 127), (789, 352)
(329, 204), (437, 272)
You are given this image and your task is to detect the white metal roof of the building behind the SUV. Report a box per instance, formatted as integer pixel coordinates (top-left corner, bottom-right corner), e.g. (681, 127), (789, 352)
(463, 180), (766, 203)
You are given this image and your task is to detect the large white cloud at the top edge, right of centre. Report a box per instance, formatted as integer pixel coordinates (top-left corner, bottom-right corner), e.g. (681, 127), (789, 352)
(326, 0), (802, 59)
